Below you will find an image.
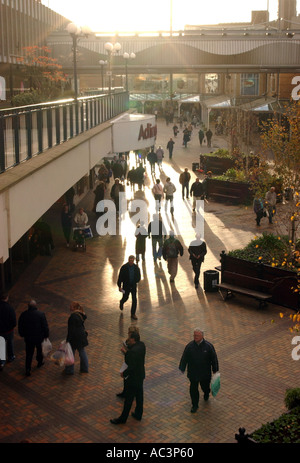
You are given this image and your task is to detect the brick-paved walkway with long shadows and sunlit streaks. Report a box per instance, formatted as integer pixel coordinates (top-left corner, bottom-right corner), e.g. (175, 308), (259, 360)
(0, 121), (299, 444)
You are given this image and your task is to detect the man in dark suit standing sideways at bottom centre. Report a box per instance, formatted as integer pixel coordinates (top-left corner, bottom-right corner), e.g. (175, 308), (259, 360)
(110, 332), (146, 424)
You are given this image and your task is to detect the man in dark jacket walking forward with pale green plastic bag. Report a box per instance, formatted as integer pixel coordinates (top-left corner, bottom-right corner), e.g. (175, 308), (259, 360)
(179, 328), (219, 413)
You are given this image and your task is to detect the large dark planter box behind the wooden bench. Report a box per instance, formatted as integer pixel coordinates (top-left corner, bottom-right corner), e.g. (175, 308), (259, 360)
(221, 251), (300, 311)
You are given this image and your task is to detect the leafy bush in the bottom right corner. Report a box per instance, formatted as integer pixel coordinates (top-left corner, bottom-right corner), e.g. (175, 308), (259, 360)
(250, 407), (300, 444)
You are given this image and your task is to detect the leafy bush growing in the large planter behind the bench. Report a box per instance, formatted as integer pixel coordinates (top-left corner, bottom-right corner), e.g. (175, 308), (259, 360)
(228, 232), (295, 270)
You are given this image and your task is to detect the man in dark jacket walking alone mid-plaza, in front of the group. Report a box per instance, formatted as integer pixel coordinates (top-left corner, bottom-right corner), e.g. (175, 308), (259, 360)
(117, 256), (141, 320)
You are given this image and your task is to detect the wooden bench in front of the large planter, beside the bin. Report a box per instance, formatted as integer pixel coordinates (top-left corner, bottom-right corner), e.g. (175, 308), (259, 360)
(216, 270), (274, 308)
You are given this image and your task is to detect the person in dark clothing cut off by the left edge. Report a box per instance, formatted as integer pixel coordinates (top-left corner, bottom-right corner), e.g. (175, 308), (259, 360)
(0, 293), (17, 370)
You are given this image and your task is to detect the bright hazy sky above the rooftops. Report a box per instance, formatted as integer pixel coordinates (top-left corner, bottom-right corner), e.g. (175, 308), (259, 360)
(42, 0), (299, 32)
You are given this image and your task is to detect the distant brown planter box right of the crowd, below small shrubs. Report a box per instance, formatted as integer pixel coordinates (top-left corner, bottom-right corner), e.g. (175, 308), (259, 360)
(207, 178), (253, 204)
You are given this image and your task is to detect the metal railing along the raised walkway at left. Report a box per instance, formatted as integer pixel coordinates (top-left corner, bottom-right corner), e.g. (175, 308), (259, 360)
(0, 92), (129, 173)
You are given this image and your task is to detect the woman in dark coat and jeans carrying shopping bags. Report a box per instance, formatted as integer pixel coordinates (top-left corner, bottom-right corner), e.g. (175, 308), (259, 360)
(65, 302), (89, 375)
